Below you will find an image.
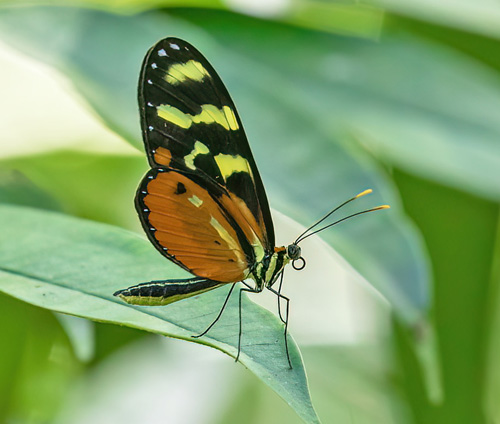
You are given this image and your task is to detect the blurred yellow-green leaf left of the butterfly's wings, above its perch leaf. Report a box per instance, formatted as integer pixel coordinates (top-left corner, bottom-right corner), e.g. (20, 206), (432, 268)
(0, 151), (148, 229)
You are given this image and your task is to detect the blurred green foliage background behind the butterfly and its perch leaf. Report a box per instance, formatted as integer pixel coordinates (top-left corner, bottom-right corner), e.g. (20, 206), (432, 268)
(0, 0), (500, 424)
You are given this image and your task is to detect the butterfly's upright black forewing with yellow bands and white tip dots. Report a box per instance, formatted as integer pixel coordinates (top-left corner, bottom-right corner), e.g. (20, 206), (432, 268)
(139, 38), (274, 252)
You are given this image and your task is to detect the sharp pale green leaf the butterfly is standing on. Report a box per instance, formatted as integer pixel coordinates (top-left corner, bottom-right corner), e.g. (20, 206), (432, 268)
(0, 205), (319, 423)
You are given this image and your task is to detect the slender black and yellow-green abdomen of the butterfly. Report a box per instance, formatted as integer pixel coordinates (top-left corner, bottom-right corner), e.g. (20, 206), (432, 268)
(114, 277), (222, 306)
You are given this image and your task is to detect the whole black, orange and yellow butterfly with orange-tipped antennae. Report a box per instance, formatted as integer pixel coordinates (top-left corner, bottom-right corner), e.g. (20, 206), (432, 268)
(115, 38), (388, 368)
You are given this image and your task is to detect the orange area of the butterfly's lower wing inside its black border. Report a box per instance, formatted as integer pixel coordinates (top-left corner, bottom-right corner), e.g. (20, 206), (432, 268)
(143, 171), (248, 283)
